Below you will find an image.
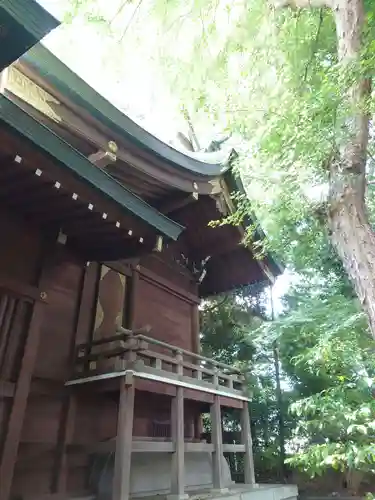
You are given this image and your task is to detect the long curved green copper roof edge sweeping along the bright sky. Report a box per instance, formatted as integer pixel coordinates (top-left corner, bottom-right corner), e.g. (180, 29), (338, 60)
(21, 44), (228, 177)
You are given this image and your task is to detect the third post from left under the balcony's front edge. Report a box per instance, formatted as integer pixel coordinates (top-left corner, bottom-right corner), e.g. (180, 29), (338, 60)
(211, 394), (228, 493)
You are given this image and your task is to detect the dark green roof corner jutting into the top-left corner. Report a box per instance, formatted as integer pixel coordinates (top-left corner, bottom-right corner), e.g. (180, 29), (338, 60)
(0, 0), (60, 71)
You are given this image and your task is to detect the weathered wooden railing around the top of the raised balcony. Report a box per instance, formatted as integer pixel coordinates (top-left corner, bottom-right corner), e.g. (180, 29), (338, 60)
(74, 328), (250, 394)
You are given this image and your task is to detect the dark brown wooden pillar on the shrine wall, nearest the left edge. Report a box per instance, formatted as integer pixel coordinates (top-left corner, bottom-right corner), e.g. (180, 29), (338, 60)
(0, 292), (46, 500)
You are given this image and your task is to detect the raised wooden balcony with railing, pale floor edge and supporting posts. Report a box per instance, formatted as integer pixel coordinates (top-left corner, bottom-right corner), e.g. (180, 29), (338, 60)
(66, 328), (255, 500)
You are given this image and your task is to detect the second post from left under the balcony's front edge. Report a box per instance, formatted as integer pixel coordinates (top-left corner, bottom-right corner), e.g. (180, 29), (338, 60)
(168, 387), (189, 500)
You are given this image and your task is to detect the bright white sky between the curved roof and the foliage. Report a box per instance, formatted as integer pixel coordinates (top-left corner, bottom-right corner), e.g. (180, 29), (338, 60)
(38, 0), (294, 313)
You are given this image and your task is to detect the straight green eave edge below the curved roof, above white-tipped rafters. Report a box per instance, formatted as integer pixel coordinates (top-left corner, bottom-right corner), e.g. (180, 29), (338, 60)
(0, 95), (183, 240)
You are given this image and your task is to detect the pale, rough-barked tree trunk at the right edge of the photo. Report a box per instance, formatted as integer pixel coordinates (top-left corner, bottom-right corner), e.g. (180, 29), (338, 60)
(274, 0), (375, 338)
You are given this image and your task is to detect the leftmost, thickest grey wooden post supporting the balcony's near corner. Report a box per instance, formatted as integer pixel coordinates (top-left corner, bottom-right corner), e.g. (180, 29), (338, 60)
(112, 374), (135, 500)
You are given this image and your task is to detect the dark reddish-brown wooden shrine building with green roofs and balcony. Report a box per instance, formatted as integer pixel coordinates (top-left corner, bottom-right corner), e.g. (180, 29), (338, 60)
(0, 0), (280, 500)
